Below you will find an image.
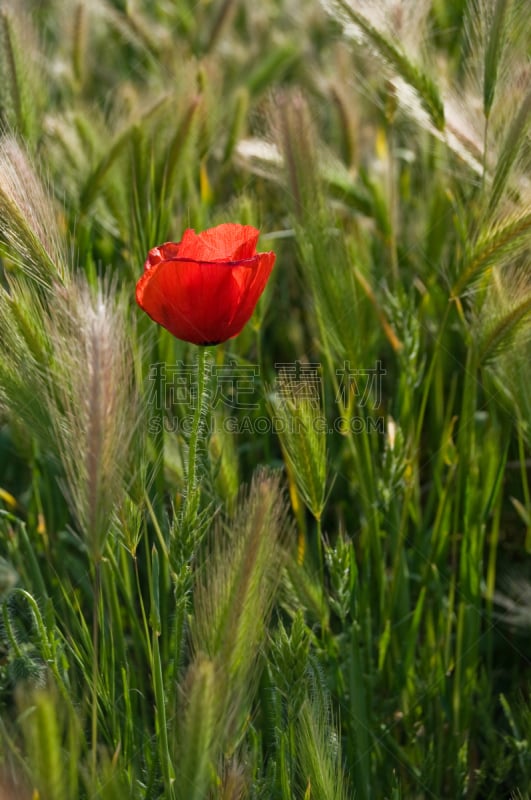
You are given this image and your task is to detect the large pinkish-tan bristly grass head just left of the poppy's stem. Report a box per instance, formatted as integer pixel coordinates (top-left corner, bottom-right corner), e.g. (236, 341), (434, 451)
(47, 280), (138, 559)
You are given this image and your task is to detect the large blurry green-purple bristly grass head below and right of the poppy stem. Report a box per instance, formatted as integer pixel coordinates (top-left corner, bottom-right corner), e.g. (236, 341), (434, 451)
(191, 470), (289, 728)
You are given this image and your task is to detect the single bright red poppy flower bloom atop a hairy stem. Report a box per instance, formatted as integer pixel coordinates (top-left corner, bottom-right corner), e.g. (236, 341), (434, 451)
(136, 223), (275, 345)
